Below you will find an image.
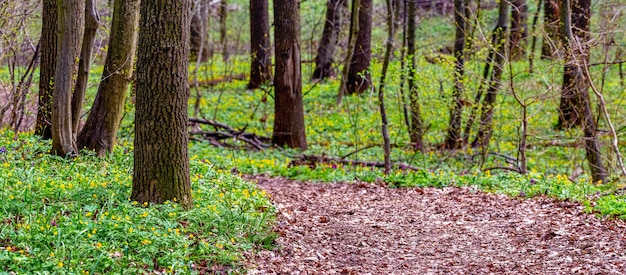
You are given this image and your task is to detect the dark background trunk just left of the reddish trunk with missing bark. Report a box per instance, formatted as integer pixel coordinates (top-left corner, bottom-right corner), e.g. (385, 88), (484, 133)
(248, 0), (272, 89)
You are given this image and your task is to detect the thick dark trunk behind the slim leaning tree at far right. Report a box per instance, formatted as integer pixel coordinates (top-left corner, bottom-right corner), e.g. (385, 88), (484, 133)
(556, 0), (591, 129)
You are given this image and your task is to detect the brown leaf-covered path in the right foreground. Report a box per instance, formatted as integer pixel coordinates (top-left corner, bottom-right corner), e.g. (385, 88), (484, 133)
(243, 176), (626, 274)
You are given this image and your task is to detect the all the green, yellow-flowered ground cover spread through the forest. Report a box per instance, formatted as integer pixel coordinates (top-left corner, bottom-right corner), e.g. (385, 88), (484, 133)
(0, 1), (626, 274)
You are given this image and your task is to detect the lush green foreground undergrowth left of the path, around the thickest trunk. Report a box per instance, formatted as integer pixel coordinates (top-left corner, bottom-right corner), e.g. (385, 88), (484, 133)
(0, 130), (275, 274)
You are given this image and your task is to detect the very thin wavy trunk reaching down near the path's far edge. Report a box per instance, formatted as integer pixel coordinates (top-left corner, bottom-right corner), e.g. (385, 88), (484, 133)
(378, 0), (392, 175)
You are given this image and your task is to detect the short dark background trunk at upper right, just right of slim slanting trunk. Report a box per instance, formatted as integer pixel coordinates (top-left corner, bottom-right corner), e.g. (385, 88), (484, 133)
(509, 0), (528, 60)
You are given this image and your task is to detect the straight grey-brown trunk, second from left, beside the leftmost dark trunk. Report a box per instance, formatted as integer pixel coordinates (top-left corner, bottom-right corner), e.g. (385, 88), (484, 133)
(51, 0), (85, 157)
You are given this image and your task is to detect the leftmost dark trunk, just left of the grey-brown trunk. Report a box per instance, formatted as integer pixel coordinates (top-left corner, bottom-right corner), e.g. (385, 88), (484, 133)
(35, 0), (58, 139)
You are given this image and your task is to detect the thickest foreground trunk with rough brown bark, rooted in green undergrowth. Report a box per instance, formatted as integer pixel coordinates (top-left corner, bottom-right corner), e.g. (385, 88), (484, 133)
(131, 0), (193, 208)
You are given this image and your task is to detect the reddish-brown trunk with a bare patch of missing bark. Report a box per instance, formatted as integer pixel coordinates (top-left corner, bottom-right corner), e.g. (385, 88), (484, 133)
(272, 0), (307, 150)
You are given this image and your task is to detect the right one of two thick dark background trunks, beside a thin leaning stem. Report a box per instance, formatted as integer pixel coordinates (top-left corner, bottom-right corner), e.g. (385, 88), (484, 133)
(346, 0), (373, 94)
